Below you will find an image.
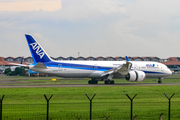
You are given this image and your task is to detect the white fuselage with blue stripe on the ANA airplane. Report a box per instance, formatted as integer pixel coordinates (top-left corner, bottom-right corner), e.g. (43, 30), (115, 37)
(29, 60), (172, 78)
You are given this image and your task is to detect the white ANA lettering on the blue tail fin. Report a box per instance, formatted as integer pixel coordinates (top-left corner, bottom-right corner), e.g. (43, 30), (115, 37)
(30, 42), (45, 59)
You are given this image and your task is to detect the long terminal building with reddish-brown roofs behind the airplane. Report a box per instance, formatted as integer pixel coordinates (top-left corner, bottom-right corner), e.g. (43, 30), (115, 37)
(0, 56), (180, 73)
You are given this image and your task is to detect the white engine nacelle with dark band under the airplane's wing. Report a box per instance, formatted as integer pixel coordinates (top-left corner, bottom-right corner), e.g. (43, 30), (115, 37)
(125, 71), (146, 82)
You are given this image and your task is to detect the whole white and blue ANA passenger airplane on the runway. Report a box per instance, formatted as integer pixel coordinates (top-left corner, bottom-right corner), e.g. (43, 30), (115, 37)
(21, 34), (172, 84)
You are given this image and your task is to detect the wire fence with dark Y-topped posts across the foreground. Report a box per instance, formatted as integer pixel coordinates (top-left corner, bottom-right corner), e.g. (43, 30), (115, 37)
(0, 95), (180, 120)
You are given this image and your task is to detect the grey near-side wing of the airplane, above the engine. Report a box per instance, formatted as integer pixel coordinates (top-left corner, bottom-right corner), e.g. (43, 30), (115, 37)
(101, 61), (132, 77)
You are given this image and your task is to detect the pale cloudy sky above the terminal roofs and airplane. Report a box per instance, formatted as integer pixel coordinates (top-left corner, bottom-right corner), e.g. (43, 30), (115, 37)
(0, 0), (180, 58)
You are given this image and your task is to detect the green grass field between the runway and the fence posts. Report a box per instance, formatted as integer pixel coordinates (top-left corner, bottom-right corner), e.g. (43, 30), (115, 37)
(0, 75), (180, 120)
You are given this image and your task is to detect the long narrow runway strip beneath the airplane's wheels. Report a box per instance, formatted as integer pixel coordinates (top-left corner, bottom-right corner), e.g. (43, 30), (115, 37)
(0, 79), (180, 88)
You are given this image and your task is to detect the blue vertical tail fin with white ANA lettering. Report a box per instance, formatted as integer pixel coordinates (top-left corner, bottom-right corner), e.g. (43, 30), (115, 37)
(25, 34), (51, 63)
